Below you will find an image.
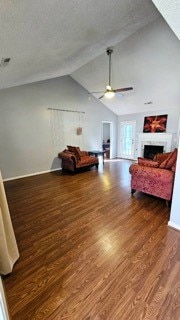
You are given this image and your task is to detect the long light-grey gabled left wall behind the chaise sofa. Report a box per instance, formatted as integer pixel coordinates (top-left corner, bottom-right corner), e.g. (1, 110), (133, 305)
(0, 76), (117, 179)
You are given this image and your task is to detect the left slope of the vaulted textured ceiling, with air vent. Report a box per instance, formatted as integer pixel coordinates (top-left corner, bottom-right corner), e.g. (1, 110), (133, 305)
(0, 0), (159, 89)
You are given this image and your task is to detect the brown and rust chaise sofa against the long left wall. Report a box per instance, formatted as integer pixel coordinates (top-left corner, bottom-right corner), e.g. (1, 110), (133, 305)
(58, 146), (99, 172)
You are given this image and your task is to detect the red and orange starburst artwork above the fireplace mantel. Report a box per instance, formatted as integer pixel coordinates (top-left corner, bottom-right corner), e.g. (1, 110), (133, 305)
(143, 114), (168, 132)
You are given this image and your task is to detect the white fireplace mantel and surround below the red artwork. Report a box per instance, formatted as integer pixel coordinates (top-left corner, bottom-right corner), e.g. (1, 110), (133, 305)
(137, 133), (172, 157)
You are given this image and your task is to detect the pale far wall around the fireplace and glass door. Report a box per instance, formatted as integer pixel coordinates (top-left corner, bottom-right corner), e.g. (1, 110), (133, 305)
(117, 107), (180, 159)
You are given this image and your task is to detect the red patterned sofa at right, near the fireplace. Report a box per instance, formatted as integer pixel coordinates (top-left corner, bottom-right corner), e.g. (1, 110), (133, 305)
(129, 149), (177, 204)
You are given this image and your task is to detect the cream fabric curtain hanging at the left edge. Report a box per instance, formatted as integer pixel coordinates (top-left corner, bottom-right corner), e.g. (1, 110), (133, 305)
(0, 171), (19, 275)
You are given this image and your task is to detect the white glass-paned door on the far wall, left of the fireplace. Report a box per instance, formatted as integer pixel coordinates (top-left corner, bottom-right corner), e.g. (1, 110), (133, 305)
(120, 121), (136, 159)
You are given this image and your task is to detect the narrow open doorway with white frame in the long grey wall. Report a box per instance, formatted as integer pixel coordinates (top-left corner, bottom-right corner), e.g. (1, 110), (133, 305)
(101, 121), (112, 159)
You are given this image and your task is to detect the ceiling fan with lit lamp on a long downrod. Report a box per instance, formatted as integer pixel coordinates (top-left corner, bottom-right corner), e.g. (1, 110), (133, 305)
(91, 48), (133, 99)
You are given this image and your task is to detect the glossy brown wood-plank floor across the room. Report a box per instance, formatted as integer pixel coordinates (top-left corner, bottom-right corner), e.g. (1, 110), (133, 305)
(3, 160), (180, 320)
